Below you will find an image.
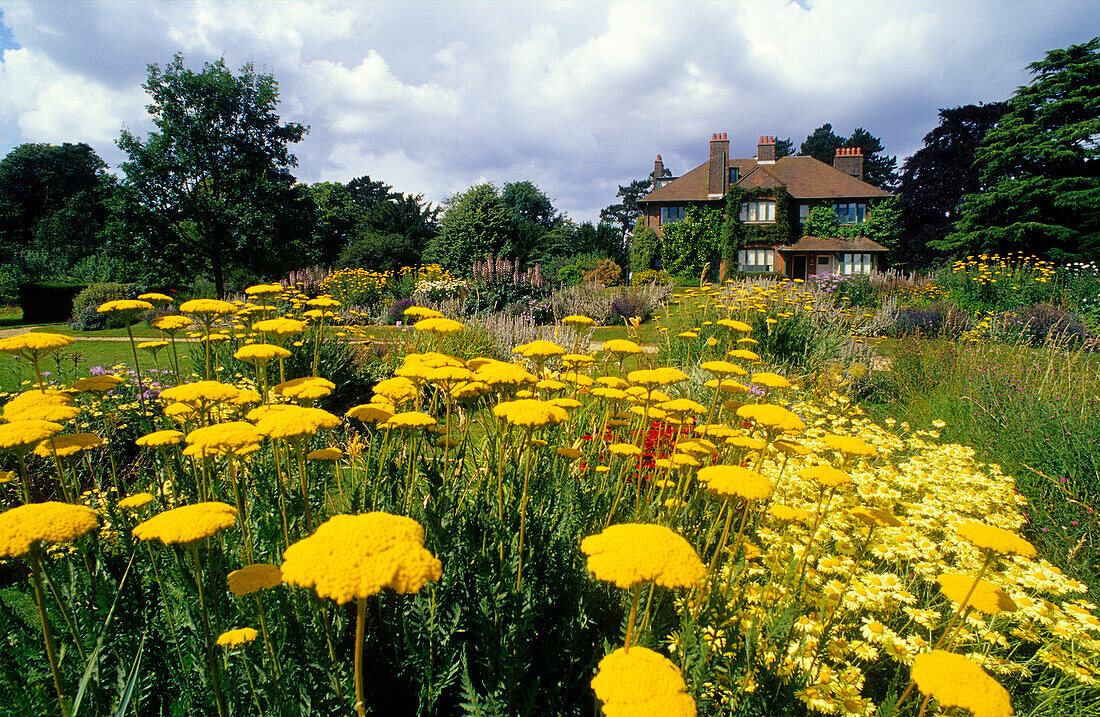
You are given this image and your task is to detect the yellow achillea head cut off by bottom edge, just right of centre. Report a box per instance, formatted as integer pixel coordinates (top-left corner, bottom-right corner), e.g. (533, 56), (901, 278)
(592, 647), (695, 717)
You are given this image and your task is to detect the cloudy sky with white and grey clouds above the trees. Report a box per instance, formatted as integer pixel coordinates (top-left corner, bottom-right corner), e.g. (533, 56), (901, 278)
(0, 0), (1100, 220)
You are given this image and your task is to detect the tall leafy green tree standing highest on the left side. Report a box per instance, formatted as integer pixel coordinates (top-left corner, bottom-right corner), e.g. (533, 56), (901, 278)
(119, 54), (308, 295)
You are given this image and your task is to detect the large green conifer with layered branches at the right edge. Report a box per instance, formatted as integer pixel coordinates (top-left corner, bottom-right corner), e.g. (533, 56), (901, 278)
(936, 37), (1100, 261)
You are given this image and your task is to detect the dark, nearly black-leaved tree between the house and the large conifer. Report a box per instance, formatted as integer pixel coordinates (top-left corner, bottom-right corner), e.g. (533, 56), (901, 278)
(892, 102), (1008, 268)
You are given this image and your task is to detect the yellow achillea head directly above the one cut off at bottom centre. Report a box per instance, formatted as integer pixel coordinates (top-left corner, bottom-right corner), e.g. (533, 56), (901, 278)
(581, 523), (706, 587)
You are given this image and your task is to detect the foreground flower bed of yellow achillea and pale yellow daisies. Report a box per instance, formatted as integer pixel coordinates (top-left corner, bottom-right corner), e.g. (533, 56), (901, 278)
(0, 284), (1100, 717)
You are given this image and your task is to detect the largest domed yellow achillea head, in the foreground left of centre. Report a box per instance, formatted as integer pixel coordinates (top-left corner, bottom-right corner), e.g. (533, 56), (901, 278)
(283, 512), (442, 605)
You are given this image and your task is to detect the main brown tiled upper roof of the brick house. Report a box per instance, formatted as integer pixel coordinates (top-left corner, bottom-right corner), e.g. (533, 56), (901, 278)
(638, 156), (892, 202)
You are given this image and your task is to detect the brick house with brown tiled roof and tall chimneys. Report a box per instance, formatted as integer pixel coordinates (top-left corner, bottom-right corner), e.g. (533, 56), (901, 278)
(638, 133), (892, 279)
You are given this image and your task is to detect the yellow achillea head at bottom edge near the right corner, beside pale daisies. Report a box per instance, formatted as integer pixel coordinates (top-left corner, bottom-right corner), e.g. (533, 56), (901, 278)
(912, 650), (1012, 717)
